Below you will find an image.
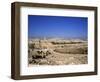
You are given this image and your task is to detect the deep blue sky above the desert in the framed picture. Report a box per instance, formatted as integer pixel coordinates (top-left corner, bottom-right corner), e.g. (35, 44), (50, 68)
(28, 15), (88, 38)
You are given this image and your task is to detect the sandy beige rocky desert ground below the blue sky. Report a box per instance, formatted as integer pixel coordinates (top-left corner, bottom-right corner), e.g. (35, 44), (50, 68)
(28, 39), (88, 66)
